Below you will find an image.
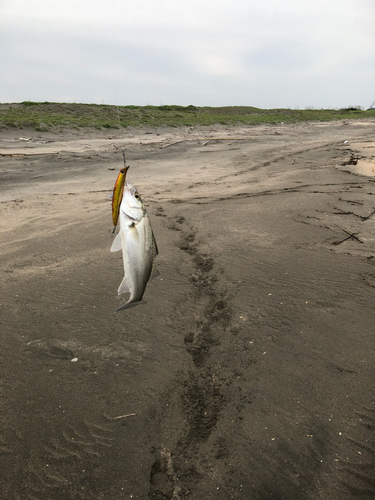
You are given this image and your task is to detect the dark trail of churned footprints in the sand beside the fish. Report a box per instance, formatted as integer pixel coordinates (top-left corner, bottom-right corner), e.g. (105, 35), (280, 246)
(149, 207), (231, 500)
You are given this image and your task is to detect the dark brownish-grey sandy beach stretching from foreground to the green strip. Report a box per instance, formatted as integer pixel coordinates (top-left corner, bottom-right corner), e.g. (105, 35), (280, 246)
(0, 121), (375, 500)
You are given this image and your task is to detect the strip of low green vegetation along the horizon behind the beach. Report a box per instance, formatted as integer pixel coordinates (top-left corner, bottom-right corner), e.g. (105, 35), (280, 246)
(0, 101), (375, 131)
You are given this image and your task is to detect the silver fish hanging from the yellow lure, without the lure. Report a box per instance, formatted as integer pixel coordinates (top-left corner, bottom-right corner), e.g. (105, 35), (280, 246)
(111, 182), (159, 312)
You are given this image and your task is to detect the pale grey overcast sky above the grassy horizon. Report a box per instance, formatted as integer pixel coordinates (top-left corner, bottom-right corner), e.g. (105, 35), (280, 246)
(0, 0), (375, 108)
